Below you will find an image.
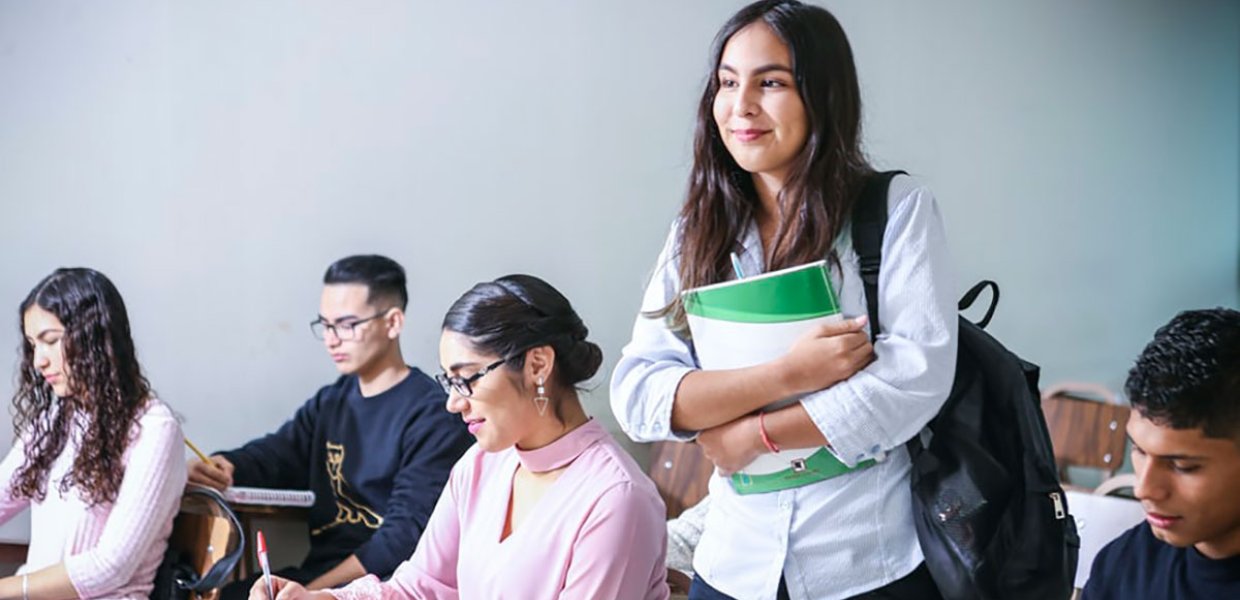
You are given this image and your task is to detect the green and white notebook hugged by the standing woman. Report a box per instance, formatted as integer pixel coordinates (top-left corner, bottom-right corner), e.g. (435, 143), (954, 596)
(681, 260), (868, 493)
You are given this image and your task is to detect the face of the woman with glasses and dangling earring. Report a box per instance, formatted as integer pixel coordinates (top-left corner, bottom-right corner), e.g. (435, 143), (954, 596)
(439, 331), (546, 452)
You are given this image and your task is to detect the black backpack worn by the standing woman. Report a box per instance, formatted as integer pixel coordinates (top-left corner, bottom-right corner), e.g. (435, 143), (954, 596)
(852, 171), (1080, 600)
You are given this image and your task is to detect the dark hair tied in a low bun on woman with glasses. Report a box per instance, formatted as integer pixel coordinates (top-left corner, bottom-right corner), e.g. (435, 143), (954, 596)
(443, 275), (603, 421)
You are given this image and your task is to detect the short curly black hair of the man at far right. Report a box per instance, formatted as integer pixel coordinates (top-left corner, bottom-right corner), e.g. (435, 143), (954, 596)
(1123, 307), (1240, 443)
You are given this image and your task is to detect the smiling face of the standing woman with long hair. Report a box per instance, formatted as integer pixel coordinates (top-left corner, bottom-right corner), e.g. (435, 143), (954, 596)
(714, 21), (808, 182)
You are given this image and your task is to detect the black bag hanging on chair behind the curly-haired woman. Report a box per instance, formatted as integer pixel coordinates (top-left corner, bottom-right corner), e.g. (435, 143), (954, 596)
(150, 483), (246, 600)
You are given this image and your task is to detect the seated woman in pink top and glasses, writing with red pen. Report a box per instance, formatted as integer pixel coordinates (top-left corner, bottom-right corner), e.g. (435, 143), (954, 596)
(250, 275), (668, 600)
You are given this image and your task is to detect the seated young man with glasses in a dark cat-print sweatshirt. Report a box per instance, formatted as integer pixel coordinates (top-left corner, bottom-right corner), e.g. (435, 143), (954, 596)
(188, 255), (474, 600)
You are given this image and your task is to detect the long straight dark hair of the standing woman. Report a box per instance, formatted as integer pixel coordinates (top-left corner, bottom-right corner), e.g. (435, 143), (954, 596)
(650, 0), (873, 331)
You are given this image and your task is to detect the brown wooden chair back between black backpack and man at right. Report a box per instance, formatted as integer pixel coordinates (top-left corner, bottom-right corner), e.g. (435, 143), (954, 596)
(1042, 383), (1131, 487)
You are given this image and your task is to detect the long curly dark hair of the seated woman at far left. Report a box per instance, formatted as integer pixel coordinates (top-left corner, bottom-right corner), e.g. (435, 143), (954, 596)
(11, 268), (151, 506)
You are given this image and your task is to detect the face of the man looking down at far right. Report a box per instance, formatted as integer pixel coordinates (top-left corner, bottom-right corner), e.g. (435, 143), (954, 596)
(1128, 410), (1240, 559)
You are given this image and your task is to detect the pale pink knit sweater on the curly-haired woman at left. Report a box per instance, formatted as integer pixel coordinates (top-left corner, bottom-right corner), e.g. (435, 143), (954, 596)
(0, 399), (186, 599)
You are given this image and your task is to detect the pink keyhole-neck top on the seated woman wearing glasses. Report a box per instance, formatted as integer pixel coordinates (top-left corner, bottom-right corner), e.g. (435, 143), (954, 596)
(330, 420), (668, 600)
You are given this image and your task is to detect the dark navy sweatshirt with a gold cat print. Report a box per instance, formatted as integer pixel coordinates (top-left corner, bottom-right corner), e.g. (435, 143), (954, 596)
(222, 368), (474, 578)
